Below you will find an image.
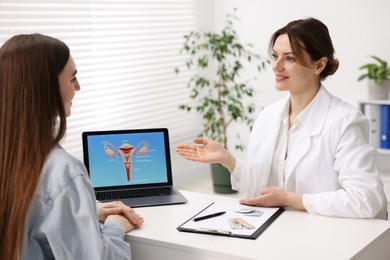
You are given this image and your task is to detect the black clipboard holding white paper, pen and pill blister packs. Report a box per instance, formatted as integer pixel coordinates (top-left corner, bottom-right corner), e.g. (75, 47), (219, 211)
(177, 202), (284, 239)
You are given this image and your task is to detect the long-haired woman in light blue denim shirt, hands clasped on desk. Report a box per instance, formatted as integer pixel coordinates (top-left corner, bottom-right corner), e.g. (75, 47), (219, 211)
(0, 34), (143, 259)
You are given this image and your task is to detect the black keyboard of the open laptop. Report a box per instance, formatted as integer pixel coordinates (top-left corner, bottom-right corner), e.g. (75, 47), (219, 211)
(96, 187), (176, 200)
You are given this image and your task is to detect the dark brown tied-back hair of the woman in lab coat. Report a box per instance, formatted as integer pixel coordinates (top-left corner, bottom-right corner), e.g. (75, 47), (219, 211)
(269, 18), (339, 80)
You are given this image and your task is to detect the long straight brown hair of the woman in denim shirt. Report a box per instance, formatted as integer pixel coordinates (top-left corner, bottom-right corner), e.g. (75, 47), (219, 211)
(0, 34), (70, 259)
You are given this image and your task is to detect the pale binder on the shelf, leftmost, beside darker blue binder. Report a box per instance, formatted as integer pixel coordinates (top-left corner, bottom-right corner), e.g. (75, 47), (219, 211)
(364, 104), (381, 148)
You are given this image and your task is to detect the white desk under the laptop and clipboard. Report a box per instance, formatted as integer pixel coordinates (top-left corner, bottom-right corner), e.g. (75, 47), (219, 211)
(126, 191), (390, 260)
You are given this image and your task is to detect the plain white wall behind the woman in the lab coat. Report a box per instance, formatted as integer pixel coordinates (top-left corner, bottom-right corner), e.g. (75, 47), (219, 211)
(173, 0), (390, 187)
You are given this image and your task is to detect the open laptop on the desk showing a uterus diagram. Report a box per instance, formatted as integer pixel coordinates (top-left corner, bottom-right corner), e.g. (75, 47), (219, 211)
(82, 128), (187, 208)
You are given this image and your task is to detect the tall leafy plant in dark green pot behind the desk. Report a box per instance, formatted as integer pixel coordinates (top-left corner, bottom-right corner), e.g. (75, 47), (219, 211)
(175, 10), (269, 193)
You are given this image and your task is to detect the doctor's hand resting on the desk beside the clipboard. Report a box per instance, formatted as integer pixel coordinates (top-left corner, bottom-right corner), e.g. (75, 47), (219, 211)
(240, 187), (305, 210)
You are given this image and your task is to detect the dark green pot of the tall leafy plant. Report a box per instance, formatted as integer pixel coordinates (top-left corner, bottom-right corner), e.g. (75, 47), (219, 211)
(211, 164), (237, 194)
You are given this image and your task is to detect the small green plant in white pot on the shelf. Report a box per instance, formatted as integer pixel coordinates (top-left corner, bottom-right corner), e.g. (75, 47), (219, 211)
(358, 56), (390, 99)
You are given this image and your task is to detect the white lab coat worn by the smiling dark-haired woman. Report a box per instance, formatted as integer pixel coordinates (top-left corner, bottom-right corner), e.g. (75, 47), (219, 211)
(231, 86), (387, 219)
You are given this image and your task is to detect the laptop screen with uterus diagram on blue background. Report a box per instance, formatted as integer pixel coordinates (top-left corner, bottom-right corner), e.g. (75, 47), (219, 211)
(83, 128), (172, 189)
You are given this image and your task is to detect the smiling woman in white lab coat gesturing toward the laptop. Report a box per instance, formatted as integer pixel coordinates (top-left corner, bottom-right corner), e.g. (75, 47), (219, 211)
(176, 18), (386, 219)
